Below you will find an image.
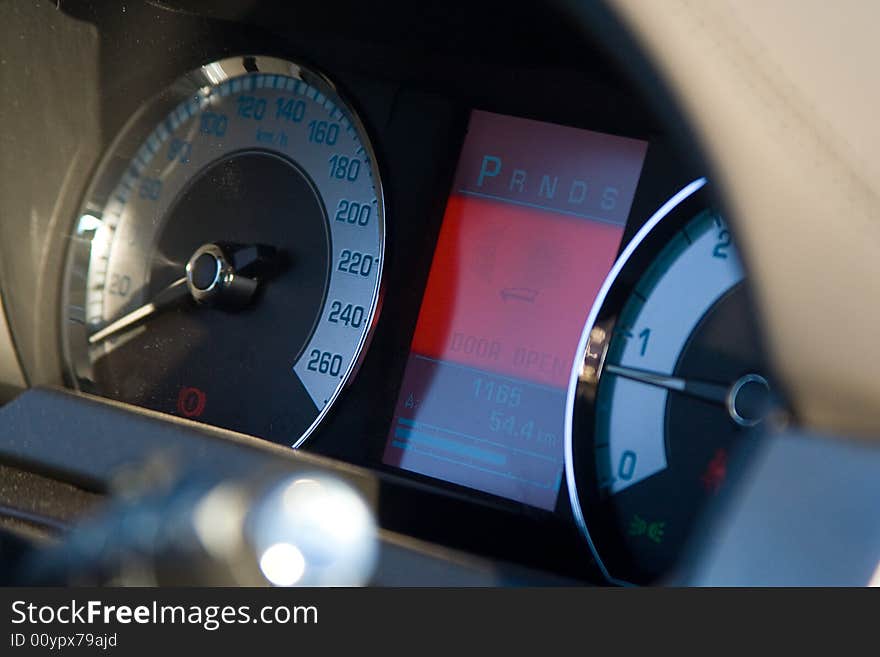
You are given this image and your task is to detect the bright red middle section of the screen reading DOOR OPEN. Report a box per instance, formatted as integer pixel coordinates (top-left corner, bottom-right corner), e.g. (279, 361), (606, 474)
(412, 194), (623, 388)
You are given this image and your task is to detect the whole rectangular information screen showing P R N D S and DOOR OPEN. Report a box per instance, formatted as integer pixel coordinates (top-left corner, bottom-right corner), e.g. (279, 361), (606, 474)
(383, 111), (647, 509)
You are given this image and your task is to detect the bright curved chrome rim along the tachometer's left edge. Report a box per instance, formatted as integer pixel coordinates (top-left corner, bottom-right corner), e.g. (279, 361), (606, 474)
(564, 178), (707, 586)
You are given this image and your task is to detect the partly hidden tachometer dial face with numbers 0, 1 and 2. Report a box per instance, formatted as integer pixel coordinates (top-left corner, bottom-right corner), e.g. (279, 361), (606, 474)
(568, 181), (771, 582)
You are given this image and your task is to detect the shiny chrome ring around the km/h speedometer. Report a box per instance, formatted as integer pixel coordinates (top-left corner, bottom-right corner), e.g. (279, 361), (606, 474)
(59, 55), (387, 448)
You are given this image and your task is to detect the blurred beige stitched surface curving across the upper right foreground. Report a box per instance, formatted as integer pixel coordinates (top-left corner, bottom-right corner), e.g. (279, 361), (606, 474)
(610, 0), (880, 435)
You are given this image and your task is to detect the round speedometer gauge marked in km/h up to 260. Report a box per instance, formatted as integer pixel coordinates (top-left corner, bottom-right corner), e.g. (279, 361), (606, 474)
(64, 57), (385, 446)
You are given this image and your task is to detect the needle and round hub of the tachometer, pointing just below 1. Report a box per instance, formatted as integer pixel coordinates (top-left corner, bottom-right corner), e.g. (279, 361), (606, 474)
(605, 363), (770, 426)
